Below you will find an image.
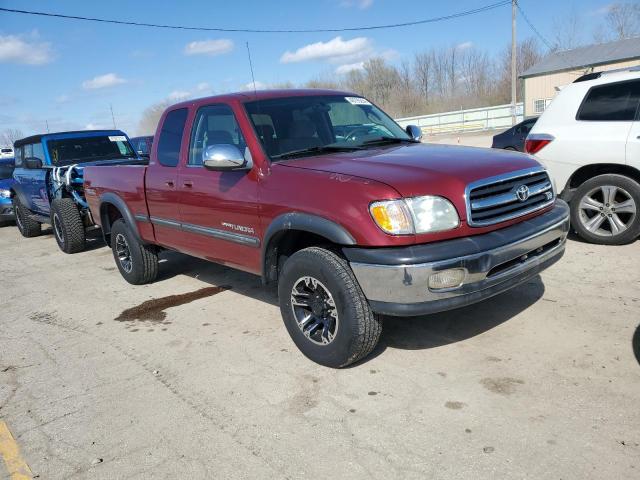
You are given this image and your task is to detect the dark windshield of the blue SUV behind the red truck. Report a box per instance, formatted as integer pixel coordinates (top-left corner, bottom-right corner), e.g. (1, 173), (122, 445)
(47, 135), (137, 165)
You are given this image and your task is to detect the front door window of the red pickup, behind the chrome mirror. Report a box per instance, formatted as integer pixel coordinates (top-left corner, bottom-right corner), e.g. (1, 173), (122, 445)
(189, 105), (247, 165)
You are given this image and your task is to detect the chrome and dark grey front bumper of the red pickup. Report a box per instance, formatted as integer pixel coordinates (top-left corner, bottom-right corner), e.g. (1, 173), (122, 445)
(343, 200), (569, 316)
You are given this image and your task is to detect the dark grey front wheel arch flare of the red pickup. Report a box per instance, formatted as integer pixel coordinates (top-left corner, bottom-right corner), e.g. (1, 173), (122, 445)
(261, 212), (356, 284)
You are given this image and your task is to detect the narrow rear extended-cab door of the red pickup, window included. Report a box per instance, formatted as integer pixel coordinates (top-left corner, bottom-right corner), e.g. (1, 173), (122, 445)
(145, 108), (188, 247)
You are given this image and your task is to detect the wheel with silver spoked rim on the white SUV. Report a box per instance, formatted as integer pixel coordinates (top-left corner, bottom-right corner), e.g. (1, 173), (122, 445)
(571, 174), (640, 245)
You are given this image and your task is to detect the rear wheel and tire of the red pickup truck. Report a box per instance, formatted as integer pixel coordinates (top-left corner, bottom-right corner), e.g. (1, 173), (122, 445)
(111, 218), (158, 285)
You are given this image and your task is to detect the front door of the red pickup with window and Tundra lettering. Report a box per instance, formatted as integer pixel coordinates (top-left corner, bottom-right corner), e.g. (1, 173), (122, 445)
(178, 104), (260, 271)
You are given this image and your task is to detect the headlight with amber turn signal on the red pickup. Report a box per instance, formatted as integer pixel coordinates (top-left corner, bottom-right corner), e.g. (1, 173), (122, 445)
(369, 195), (460, 235)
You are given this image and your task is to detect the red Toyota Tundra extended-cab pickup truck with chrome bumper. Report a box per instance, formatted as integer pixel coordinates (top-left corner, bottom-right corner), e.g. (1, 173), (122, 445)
(84, 90), (569, 367)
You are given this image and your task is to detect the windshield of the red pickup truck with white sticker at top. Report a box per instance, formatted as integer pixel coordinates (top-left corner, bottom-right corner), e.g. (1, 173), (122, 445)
(245, 95), (412, 160)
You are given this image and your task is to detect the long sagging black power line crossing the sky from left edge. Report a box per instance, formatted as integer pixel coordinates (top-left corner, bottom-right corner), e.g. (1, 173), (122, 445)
(0, 0), (511, 33)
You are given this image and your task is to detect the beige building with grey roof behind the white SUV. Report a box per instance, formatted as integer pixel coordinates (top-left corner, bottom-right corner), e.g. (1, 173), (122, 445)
(520, 37), (640, 117)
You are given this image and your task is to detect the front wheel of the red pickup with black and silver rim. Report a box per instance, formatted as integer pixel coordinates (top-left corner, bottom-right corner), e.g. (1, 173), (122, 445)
(278, 247), (382, 368)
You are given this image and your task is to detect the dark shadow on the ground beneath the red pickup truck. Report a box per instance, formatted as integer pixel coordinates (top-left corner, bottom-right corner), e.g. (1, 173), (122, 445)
(158, 252), (544, 367)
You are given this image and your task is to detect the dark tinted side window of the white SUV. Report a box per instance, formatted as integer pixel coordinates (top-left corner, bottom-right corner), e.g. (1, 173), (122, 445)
(577, 80), (640, 122)
